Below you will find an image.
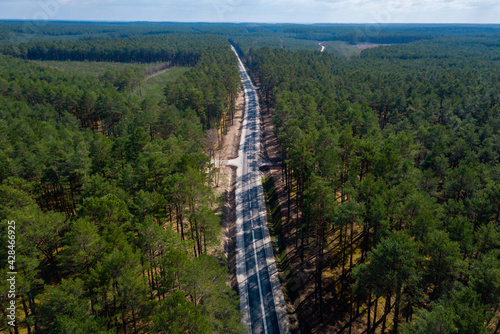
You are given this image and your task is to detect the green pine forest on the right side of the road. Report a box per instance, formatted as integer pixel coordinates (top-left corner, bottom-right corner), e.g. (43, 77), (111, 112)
(246, 36), (500, 334)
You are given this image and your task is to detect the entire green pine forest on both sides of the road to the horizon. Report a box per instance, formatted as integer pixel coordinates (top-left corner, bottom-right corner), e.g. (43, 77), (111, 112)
(0, 22), (500, 334)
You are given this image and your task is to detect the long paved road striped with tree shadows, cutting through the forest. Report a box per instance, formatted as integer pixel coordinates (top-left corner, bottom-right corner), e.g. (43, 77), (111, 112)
(228, 48), (289, 334)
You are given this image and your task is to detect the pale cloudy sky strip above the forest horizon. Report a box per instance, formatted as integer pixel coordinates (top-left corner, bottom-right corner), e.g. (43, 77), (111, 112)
(0, 0), (500, 23)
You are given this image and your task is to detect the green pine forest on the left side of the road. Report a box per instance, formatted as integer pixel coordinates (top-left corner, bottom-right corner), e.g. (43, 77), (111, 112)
(0, 33), (242, 334)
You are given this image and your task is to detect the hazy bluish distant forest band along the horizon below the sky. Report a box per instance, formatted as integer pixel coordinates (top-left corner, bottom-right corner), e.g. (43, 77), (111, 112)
(4, 21), (500, 51)
